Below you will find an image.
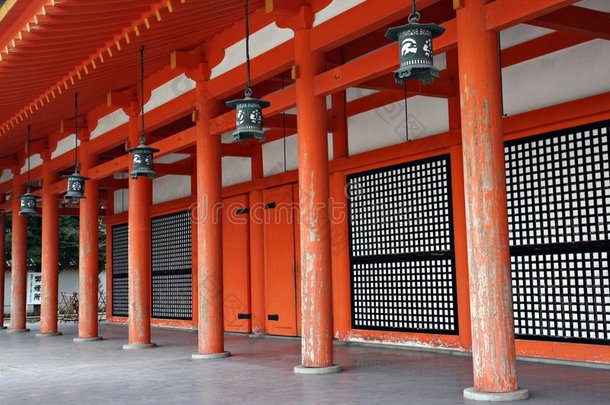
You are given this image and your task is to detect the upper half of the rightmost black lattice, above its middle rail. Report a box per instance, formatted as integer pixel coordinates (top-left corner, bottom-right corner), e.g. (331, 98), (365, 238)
(505, 123), (610, 246)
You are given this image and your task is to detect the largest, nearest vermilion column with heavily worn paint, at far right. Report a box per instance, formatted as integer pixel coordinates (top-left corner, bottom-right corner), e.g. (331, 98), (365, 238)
(457, 0), (527, 400)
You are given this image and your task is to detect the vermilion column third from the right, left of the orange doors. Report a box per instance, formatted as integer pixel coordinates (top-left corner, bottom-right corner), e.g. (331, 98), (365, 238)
(192, 81), (230, 359)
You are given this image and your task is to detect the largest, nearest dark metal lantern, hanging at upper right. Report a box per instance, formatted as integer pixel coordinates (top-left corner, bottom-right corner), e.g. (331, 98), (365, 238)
(385, 2), (445, 84)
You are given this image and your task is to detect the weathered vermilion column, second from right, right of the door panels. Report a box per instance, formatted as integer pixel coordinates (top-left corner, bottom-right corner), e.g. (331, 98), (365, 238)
(294, 29), (341, 374)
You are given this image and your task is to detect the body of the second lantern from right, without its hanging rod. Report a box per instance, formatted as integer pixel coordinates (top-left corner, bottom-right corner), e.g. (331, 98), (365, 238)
(226, 96), (271, 142)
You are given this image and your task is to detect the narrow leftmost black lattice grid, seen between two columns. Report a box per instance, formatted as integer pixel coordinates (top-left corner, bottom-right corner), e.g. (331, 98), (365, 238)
(112, 224), (129, 316)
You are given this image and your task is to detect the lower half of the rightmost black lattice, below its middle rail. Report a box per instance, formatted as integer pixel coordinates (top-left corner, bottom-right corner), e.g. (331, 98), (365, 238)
(511, 252), (610, 343)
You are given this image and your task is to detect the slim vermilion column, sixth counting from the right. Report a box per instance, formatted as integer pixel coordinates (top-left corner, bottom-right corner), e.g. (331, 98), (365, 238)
(36, 150), (61, 336)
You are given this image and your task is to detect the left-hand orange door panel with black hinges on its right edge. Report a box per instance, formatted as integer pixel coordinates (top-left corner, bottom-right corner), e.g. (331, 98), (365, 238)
(222, 195), (251, 333)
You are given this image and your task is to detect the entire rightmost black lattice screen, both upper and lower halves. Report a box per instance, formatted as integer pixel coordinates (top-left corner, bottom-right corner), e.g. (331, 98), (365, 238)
(505, 121), (610, 344)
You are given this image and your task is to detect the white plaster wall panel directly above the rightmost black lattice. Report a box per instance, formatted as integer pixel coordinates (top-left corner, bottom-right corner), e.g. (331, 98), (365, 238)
(502, 39), (610, 115)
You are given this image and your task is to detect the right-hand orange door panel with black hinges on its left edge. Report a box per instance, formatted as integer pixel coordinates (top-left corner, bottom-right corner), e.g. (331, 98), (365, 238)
(263, 185), (297, 336)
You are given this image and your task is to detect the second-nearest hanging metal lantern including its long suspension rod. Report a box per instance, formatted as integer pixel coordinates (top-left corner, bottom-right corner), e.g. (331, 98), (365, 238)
(226, 0), (271, 142)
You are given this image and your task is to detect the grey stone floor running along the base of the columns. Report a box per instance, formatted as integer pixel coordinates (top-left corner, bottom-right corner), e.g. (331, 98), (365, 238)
(0, 324), (610, 405)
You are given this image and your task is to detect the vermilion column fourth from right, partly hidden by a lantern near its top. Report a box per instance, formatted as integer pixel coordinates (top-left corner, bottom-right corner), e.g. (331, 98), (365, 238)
(123, 115), (155, 350)
